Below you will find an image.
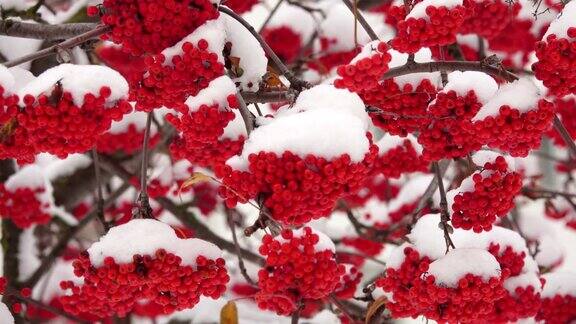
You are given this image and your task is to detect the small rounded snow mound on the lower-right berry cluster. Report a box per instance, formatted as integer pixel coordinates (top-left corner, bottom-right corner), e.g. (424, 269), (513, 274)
(424, 248), (500, 288)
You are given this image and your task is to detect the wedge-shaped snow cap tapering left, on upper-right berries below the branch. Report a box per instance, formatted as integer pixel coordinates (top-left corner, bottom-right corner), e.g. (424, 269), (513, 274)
(472, 78), (542, 121)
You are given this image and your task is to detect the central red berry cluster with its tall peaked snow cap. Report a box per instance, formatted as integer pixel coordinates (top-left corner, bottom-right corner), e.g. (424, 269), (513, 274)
(216, 86), (378, 224)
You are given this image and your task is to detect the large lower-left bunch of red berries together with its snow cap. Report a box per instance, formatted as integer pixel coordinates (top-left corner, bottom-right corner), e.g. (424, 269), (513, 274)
(60, 220), (229, 318)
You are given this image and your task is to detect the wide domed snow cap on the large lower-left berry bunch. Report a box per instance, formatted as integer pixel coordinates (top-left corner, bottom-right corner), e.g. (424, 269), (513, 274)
(88, 219), (222, 267)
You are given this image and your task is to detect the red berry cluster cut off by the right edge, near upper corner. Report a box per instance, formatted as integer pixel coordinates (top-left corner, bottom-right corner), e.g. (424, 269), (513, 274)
(532, 31), (576, 97)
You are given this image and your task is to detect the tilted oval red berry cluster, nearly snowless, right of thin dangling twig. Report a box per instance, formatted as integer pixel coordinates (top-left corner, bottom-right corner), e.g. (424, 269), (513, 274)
(452, 156), (522, 233)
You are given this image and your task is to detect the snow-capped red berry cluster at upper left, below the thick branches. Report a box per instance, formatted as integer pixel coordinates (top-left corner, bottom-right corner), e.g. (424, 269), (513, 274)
(17, 64), (132, 158)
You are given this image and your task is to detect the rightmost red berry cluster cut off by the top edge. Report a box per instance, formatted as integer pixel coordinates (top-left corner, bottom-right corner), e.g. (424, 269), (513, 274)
(460, 0), (522, 39)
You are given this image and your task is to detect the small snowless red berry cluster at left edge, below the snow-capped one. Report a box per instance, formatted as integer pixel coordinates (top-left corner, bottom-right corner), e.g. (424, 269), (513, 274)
(0, 184), (52, 228)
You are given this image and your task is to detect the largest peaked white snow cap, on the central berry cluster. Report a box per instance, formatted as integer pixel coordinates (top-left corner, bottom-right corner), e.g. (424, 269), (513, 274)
(227, 86), (370, 170)
